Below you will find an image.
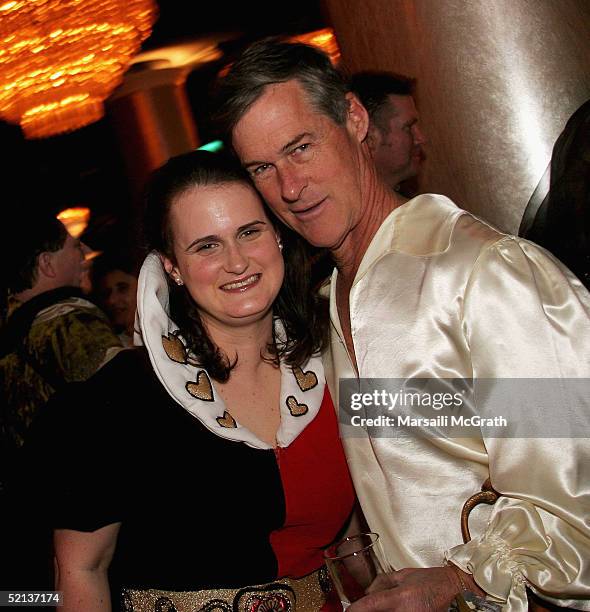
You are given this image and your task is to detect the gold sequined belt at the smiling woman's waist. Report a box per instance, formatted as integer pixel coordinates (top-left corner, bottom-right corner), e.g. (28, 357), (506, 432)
(123, 567), (332, 612)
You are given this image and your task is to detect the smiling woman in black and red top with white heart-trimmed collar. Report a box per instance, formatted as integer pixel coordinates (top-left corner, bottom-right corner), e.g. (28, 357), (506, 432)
(30, 151), (353, 612)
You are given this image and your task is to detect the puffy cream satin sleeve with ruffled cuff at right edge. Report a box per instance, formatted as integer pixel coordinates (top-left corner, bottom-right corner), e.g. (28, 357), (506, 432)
(445, 237), (590, 612)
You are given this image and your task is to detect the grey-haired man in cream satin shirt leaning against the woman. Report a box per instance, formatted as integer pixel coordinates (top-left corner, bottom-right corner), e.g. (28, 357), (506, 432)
(218, 41), (590, 612)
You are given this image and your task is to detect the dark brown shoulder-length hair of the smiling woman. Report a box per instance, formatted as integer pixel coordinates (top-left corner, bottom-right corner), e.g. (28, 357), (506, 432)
(144, 151), (328, 382)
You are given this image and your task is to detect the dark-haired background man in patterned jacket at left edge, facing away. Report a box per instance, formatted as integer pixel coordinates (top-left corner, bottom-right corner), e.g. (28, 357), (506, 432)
(0, 212), (122, 468)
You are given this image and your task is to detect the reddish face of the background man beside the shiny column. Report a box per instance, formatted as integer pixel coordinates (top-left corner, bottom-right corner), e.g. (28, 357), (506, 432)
(369, 95), (426, 189)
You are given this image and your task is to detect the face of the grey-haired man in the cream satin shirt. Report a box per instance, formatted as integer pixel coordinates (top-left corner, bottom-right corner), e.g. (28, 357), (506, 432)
(232, 80), (367, 250)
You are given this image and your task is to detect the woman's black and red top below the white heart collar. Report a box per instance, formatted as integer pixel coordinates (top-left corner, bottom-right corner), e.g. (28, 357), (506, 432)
(12, 349), (353, 604)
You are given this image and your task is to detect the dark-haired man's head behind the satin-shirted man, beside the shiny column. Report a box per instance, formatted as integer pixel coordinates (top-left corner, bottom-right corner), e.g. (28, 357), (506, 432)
(350, 71), (426, 195)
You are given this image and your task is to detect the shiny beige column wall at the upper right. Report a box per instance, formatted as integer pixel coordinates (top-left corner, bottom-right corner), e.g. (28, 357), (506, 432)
(325, 0), (590, 233)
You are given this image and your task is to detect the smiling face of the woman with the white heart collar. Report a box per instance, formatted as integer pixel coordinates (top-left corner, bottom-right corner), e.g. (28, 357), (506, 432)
(164, 182), (284, 327)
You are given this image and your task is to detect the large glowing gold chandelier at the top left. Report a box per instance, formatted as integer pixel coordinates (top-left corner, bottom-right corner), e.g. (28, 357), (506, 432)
(0, 0), (157, 138)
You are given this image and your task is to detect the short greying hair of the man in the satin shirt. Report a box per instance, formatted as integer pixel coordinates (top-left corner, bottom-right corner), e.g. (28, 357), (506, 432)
(215, 38), (348, 137)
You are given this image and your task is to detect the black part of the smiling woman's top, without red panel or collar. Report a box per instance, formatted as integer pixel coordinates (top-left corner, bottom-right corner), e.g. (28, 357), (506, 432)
(29, 350), (285, 590)
